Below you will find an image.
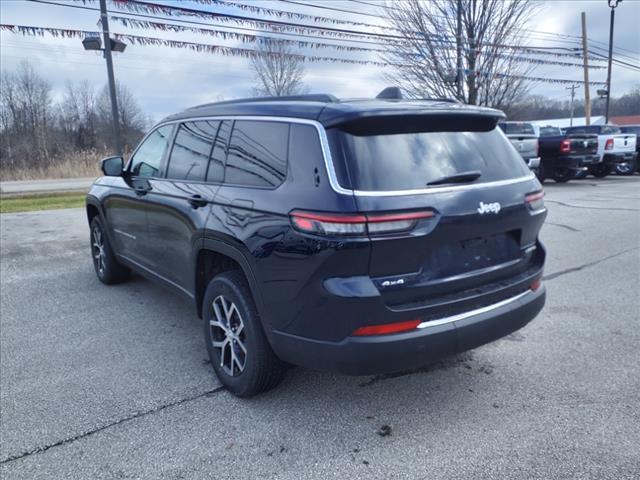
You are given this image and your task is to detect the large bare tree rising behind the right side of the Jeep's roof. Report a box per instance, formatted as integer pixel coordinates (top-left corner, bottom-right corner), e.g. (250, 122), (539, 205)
(384, 0), (537, 108)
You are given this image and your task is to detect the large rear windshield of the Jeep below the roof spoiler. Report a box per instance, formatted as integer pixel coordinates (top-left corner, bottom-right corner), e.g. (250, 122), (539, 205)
(328, 120), (529, 191)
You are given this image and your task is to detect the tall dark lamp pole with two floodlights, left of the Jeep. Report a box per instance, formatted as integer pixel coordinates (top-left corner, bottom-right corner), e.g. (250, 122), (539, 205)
(82, 0), (127, 155)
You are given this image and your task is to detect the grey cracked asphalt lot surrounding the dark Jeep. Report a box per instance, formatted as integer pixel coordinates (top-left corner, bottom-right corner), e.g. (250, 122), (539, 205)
(0, 176), (640, 480)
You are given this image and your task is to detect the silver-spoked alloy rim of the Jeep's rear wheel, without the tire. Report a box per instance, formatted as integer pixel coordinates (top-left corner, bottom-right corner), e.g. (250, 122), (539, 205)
(209, 295), (247, 377)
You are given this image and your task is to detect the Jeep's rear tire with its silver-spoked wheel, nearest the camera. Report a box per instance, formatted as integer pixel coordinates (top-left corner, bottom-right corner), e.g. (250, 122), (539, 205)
(202, 270), (286, 397)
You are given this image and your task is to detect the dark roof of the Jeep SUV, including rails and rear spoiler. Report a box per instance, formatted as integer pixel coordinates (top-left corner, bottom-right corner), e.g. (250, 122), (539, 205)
(160, 94), (504, 127)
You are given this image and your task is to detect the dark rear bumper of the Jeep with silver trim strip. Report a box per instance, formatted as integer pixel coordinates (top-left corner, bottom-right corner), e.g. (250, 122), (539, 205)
(273, 285), (546, 375)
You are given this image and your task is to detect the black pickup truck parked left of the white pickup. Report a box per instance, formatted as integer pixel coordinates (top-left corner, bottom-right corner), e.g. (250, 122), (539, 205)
(538, 126), (600, 183)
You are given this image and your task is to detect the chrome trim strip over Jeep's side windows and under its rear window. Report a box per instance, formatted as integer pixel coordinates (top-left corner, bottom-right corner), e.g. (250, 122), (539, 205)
(138, 115), (535, 197)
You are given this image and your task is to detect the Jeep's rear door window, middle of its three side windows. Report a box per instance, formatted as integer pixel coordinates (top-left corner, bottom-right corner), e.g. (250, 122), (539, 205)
(167, 121), (220, 181)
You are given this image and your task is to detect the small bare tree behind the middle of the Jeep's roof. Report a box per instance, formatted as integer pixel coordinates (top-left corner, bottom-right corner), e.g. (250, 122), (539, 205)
(251, 42), (307, 97)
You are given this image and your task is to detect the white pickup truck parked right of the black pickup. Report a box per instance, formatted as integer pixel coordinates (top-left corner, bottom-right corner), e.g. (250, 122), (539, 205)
(567, 125), (638, 178)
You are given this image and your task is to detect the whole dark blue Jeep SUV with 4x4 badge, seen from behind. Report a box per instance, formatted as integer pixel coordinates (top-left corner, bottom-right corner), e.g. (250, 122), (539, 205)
(87, 91), (546, 396)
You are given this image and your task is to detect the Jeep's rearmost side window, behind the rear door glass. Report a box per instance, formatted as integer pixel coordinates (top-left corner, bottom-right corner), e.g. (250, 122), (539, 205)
(225, 120), (289, 187)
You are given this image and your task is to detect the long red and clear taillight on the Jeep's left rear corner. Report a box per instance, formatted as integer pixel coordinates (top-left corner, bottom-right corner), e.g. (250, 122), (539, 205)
(290, 211), (435, 236)
